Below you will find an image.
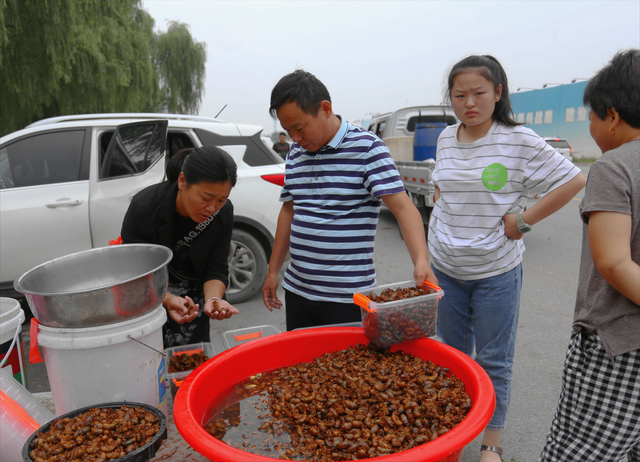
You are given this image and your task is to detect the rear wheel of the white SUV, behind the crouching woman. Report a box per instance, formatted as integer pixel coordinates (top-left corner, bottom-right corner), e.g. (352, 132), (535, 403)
(225, 229), (268, 305)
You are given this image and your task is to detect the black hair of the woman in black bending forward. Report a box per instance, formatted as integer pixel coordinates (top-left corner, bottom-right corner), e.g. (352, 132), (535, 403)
(166, 146), (238, 187)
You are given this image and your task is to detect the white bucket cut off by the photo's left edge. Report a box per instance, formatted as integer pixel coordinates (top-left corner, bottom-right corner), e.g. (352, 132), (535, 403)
(0, 297), (28, 387)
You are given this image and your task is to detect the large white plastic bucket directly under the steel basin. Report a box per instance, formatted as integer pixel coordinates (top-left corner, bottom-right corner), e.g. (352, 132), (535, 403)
(38, 306), (167, 415)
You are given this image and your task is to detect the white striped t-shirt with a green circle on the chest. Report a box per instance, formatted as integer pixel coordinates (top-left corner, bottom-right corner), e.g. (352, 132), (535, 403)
(429, 122), (580, 280)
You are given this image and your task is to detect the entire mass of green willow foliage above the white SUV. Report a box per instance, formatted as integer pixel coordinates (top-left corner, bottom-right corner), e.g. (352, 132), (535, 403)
(0, 0), (206, 135)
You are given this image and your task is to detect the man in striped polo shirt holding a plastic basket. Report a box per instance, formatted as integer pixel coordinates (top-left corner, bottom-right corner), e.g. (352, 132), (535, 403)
(262, 70), (437, 330)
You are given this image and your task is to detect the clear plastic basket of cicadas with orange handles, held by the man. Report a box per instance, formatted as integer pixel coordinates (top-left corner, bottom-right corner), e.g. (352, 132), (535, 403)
(353, 281), (444, 347)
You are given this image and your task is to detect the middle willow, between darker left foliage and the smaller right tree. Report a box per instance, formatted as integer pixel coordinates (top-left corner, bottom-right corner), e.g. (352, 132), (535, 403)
(52, 0), (159, 115)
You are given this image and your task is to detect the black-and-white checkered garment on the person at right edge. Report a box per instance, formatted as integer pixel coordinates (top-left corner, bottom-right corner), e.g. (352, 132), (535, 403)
(539, 333), (640, 462)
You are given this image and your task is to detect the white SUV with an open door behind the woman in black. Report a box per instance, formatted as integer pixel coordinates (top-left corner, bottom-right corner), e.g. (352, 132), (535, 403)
(0, 114), (284, 303)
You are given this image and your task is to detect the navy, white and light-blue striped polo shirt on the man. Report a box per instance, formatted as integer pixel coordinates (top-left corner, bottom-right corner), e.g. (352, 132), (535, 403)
(280, 120), (404, 303)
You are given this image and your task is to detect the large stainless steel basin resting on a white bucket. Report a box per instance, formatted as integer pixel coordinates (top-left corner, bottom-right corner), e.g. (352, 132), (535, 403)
(14, 244), (172, 328)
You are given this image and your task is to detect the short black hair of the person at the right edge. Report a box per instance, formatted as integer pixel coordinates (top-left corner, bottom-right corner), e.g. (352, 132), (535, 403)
(582, 48), (640, 128)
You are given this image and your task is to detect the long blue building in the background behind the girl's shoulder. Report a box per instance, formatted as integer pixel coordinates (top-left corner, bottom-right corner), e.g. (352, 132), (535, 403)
(511, 81), (601, 161)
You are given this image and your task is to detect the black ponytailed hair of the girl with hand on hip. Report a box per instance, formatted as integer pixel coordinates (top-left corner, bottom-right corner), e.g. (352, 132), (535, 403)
(446, 55), (522, 126)
